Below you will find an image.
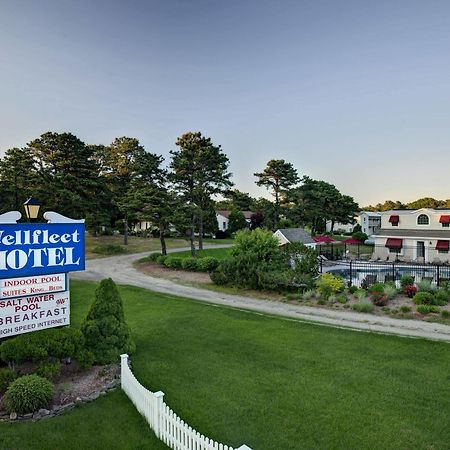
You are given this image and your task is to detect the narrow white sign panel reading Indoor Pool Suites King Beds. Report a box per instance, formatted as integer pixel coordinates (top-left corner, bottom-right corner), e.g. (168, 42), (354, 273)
(0, 273), (67, 299)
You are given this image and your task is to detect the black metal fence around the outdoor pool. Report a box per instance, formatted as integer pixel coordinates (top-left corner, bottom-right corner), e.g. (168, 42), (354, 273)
(320, 259), (450, 287)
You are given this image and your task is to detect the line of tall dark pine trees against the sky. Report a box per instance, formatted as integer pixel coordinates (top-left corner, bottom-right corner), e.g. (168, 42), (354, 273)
(0, 132), (358, 254)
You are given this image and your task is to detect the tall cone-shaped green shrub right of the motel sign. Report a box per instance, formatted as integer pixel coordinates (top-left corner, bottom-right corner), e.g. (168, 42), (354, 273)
(81, 278), (134, 364)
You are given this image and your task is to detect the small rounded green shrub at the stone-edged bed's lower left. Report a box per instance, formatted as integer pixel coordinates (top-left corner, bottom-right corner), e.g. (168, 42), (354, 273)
(4, 375), (53, 414)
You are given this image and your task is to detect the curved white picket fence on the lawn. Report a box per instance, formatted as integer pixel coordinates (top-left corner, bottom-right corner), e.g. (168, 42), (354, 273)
(120, 354), (251, 450)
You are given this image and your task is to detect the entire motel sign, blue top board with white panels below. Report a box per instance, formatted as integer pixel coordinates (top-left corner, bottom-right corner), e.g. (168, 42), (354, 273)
(0, 211), (85, 339)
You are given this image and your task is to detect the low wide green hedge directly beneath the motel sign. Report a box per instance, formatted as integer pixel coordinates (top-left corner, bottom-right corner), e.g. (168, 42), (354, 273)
(0, 328), (84, 366)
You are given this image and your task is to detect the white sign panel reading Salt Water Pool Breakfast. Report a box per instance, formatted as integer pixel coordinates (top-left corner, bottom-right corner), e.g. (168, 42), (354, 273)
(0, 291), (70, 338)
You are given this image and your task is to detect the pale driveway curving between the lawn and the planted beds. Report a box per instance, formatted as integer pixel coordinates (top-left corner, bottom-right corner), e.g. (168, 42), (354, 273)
(71, 245), (450, 342)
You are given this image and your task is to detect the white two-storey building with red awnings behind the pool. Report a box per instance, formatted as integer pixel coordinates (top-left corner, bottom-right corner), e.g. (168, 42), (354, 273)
(373, 208), (450, 263)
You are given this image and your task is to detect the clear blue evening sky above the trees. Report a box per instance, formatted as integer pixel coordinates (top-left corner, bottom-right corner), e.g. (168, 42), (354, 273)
(0, 0), (450, 206)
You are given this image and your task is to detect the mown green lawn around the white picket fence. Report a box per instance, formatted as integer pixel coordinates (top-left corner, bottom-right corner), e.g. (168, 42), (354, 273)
(0, 281), (450, 450)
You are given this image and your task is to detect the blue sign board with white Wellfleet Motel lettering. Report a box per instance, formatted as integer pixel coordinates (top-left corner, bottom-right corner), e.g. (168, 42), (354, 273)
(0, 223), (84, 278)
